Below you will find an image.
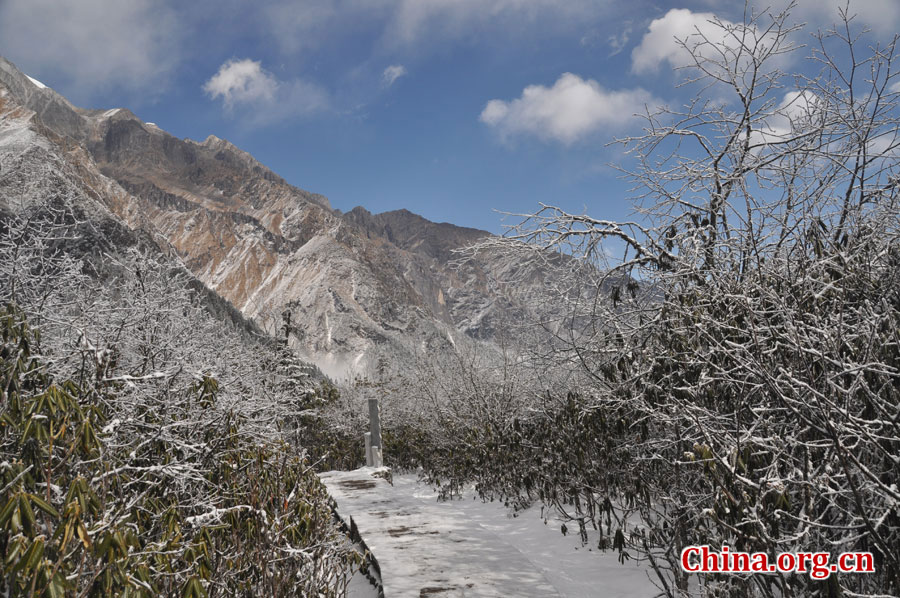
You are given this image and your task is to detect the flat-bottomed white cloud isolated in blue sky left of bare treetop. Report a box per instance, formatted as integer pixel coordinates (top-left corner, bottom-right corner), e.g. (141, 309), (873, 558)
(480, 73), (656, 145)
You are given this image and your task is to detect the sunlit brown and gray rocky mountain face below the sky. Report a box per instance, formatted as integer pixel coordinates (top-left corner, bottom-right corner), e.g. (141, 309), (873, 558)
(0, 59), (564, 377)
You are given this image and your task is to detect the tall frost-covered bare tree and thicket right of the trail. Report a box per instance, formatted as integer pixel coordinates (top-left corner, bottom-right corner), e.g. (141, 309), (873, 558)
(460, 4), (900, 596)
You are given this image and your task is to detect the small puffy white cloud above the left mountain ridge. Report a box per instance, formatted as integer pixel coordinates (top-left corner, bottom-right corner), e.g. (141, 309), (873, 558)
(203, 58), (331, 124)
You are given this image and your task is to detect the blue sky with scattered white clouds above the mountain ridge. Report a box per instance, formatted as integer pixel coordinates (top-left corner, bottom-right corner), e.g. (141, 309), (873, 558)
(0, 0), (900, 232)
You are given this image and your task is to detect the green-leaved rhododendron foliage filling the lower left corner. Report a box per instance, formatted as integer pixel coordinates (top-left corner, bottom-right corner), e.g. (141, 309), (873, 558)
(0, 306), (357, 598)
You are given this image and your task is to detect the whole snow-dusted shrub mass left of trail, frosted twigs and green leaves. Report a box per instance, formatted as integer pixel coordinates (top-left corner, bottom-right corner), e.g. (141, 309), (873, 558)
(0, 204), (358, 597)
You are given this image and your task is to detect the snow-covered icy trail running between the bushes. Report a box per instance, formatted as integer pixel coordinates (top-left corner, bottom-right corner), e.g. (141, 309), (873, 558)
(321, 468), (658, 598)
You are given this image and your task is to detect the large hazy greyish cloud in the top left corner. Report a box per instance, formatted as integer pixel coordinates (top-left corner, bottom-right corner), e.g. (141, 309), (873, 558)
(0, 0), (181, 101)
